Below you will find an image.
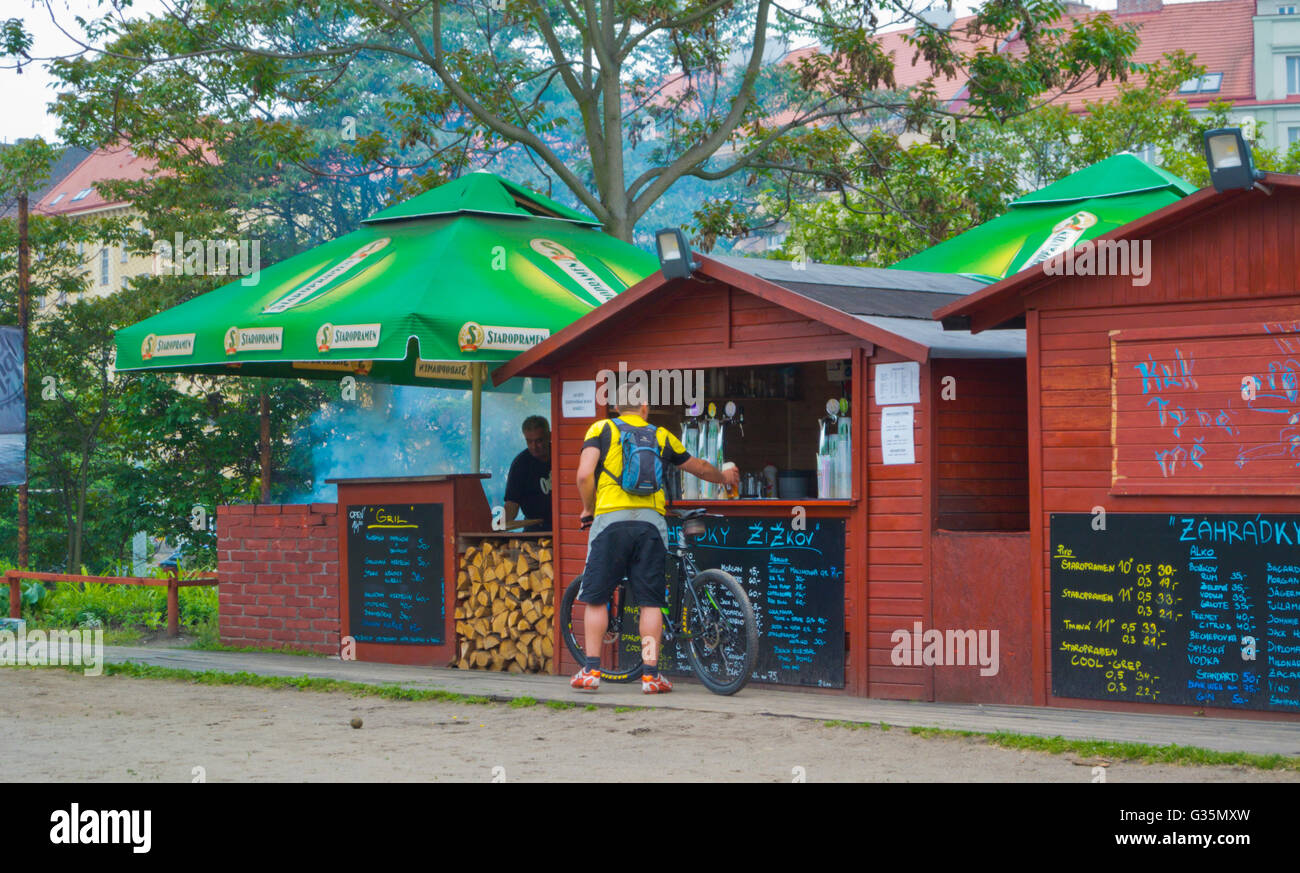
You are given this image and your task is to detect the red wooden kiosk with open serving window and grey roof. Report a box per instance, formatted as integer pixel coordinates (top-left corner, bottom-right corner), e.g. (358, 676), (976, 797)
(493, 257), (1030, 702)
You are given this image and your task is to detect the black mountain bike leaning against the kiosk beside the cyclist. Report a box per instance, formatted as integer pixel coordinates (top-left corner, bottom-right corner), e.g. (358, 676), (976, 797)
(559, 509), (758, 694)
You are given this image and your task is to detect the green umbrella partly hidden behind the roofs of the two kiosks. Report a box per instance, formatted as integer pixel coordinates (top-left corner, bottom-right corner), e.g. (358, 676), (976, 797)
(891, 155), (1196, 282)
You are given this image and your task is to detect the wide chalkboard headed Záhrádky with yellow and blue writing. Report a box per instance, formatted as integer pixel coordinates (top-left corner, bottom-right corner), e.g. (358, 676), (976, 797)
(1050, 513), (1300, 712)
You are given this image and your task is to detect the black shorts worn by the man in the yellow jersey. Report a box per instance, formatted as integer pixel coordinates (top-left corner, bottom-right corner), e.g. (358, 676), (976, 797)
(577, 521), (668, 608)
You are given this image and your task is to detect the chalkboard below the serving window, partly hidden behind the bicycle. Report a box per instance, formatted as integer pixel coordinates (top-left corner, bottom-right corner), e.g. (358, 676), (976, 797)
(623, 516), (845, 689)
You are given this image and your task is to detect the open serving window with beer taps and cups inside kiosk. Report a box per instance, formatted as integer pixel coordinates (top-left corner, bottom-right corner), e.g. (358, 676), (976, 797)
(651, 360), (855, 501)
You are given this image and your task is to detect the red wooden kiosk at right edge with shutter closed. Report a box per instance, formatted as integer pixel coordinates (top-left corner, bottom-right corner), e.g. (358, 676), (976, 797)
(935, 174), (1300, 718)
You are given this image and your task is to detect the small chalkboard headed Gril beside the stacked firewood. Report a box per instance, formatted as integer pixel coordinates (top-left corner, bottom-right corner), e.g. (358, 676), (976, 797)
(347, 503), (447, 646)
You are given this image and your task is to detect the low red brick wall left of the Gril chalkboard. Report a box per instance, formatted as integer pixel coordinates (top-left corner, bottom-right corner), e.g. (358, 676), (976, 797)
(217, 503), (339, 653)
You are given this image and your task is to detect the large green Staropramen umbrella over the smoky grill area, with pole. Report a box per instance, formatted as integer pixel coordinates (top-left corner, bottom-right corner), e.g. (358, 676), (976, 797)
(116, 171), (659, 472)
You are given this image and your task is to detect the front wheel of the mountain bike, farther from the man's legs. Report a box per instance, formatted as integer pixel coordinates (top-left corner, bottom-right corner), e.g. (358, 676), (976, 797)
(683, 570), (758, 694)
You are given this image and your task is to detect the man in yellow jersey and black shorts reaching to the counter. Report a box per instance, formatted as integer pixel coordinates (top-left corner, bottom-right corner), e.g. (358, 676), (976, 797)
(571, 404), (740, 694)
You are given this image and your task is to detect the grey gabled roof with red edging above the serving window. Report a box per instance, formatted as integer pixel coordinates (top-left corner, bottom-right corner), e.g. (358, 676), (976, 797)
(493, 253), (1024, 385)
